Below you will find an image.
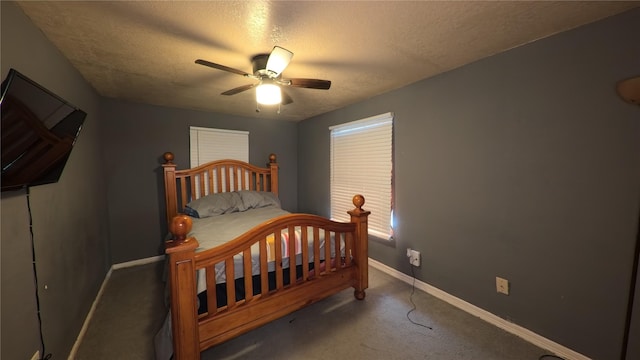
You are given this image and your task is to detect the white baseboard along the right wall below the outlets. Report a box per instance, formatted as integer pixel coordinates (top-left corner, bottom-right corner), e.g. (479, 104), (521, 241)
(369, 258), (590, 360)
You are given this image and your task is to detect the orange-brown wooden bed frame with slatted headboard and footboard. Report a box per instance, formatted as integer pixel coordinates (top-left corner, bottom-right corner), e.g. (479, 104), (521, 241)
(162, 152), (370, 360)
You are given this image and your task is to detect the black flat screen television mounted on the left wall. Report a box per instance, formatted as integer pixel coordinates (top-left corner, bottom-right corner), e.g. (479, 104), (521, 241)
(0, 69), (87, 191)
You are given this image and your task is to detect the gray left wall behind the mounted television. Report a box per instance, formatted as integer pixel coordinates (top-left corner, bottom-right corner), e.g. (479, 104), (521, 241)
(0, 1), (110, 359)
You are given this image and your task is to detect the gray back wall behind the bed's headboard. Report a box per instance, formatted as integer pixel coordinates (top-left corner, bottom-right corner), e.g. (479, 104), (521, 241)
(103, 99), (298, 264)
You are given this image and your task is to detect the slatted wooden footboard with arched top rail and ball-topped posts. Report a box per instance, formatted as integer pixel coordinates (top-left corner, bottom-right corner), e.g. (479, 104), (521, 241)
(166, 195), (370, 360)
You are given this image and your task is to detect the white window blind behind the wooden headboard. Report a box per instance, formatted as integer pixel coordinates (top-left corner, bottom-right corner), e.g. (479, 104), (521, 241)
(189, 126), (249, 197)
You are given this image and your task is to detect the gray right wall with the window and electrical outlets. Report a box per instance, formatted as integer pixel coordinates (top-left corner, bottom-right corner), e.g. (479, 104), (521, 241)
(298, 10), (640, 359)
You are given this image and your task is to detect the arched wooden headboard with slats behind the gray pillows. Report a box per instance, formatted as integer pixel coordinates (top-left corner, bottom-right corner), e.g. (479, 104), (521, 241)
(162, 152), (278, 223)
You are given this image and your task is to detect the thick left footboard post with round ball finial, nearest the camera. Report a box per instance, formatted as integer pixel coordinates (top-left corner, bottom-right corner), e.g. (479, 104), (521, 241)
(165, 215), (200, 360)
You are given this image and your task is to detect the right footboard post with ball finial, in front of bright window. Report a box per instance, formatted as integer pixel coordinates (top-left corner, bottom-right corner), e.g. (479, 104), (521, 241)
(348, 195), (371, 300)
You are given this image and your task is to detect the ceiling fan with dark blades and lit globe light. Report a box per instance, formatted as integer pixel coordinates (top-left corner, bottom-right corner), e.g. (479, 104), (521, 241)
(196, 46), (331, 111)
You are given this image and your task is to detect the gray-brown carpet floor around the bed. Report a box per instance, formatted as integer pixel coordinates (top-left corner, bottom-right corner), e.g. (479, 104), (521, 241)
(75, 262), (548, 360)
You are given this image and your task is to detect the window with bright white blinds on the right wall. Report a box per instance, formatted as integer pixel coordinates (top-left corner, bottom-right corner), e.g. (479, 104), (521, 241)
(329, 113), (393, 239)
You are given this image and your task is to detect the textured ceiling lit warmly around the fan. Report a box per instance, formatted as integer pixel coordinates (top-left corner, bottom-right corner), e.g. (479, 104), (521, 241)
(19, 1), (640, 121)
